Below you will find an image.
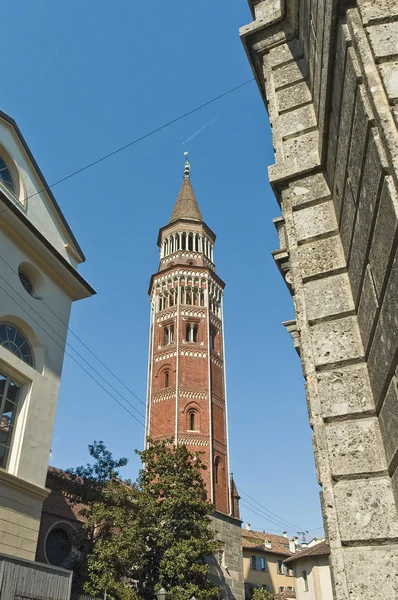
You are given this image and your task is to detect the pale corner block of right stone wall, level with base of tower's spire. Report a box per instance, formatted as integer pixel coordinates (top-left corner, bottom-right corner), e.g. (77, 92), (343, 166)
(294, 201), (337, 242)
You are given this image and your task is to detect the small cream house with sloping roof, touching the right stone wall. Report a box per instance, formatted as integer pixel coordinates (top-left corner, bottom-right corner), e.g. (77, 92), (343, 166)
(284, 540), (333, 600)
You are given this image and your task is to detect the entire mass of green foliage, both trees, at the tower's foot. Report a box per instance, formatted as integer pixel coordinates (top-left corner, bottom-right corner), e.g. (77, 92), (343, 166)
(69, 440), (220, 600)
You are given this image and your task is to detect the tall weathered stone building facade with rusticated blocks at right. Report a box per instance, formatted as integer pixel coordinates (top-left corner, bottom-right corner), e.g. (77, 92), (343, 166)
(241, 0), (398, 600)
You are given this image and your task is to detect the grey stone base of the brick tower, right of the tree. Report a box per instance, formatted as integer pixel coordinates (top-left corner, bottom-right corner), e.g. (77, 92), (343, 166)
(209, 511), (245, 600)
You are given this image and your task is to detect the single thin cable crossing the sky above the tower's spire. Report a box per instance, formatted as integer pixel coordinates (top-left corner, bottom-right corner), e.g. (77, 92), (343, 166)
(0, 78), (254, 214)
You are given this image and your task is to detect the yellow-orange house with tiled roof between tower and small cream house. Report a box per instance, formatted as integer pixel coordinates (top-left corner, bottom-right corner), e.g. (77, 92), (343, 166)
(242, 524), (297, 600)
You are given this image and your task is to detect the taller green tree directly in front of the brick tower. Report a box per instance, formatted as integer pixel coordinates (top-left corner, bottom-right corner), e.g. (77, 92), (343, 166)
(133, 440), (220, 600)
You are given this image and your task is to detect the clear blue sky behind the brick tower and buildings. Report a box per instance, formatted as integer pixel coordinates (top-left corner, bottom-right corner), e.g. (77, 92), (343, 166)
(0, 0), (322, 535)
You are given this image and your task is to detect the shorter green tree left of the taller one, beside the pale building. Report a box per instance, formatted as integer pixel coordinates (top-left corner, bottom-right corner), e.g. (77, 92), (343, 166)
(68, 441), (138, 600)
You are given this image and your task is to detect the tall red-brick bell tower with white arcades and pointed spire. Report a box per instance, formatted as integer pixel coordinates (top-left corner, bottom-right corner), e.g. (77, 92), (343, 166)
(146, 153), (233, 518)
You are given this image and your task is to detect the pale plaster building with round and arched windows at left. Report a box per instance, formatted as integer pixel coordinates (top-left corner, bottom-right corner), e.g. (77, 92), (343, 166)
(0, 112), (95, 560)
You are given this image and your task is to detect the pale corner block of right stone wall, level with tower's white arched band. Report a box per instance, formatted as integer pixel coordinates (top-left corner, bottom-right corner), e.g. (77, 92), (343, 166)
(304, 273), (354, 321)
